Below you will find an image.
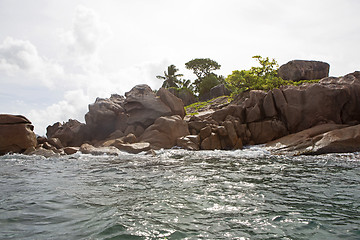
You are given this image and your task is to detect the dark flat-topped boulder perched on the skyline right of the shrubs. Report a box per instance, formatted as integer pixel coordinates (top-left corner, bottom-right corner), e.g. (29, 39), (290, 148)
(278, 60), (330, 81)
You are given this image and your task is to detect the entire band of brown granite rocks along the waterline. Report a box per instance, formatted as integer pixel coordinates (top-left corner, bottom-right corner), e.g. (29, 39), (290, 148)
(0, 68), (360, 156)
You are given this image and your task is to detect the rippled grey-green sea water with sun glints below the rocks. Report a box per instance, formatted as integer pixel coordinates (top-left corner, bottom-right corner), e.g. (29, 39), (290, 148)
(0, 147), (360, 240)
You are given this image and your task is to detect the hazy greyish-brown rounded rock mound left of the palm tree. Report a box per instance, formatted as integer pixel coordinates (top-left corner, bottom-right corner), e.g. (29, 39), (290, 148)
(47, 85), (185, 149)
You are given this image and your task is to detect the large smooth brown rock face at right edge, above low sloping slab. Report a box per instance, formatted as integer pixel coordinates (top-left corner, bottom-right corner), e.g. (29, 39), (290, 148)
(272, 72), (360, 133)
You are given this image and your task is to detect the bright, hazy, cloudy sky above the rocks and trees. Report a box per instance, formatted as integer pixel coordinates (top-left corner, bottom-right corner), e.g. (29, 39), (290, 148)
(0, 0), (360, 135)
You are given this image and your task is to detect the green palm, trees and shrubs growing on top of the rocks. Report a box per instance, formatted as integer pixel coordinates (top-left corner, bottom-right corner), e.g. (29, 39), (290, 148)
(157, 55), (319, 104)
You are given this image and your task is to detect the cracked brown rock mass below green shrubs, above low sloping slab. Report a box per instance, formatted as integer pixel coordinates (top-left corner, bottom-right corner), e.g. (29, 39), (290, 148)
(184, 72), (360, 152)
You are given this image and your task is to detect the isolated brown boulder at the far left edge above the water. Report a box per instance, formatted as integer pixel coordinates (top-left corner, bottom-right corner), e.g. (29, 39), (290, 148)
(0, 114), (37, 155)
